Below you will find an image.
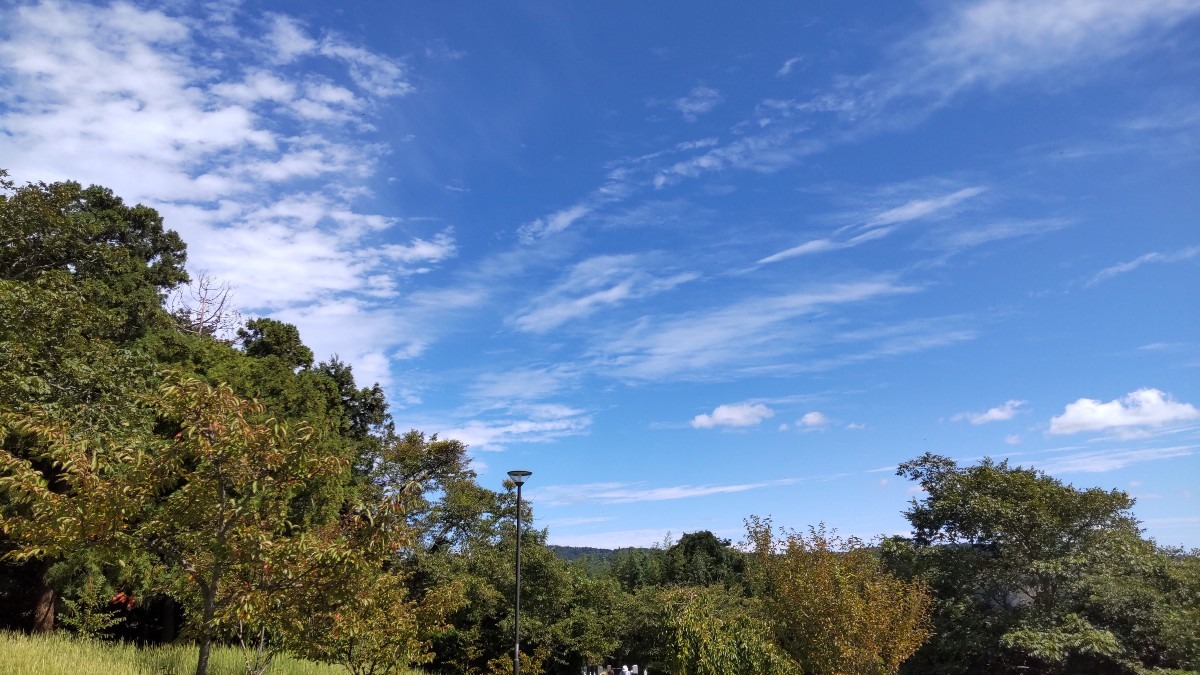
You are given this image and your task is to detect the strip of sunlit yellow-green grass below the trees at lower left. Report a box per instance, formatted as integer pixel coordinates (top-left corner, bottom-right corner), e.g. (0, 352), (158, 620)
(0, 632), (420, 675)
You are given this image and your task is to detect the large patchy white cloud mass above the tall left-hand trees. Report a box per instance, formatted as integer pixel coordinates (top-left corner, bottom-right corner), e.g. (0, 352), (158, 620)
(0, 2), (446, 400)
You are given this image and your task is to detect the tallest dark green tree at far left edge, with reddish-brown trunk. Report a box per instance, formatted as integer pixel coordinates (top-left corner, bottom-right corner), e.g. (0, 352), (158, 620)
(0, 172), (187, 631)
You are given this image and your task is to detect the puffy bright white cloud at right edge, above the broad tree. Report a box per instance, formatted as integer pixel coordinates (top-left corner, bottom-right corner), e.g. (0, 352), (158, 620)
(1049, 389), (1200, 435)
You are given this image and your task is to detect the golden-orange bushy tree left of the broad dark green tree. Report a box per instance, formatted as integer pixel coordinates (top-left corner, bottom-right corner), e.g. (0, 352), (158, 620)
(746, 518), (931, 675)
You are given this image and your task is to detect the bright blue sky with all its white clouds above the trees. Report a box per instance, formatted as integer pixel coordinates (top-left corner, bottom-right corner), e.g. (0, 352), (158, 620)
(7, 0), (1200, 546)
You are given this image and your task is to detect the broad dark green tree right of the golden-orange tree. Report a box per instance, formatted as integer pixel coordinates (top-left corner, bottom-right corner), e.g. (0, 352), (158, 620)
(884, 454), (1153, 673)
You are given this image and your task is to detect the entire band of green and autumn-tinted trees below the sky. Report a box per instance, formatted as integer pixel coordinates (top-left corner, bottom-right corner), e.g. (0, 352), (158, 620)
(0, 171), (1200, 675)
